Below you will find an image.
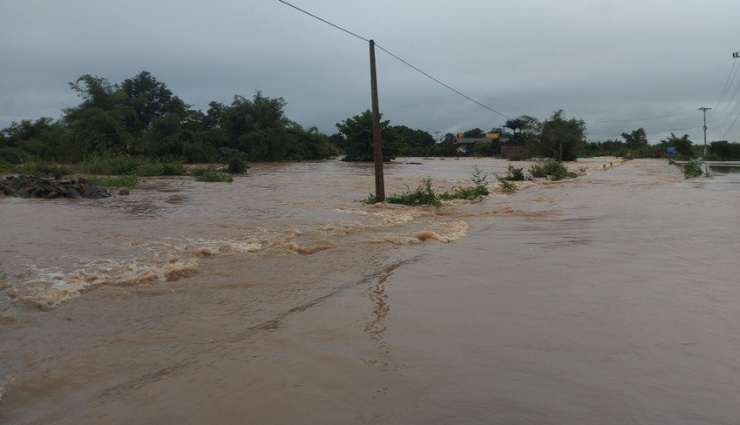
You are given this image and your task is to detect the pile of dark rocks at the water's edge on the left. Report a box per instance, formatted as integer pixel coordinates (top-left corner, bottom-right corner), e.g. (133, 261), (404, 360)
(0, 173), (111, 199)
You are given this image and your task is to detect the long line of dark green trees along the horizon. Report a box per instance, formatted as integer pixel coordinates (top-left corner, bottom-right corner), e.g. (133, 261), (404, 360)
(0, 71), (740, 163)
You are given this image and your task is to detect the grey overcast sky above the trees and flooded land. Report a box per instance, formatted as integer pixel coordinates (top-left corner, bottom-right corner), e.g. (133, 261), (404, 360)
(0, 0), (740, 143)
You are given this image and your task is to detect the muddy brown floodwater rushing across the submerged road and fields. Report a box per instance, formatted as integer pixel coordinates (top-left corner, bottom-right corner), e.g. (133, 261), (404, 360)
(0, 158), (740, 424)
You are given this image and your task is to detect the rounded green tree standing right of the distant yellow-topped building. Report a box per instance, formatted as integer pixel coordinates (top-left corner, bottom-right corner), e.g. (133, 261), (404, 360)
(540, 109), (586, 161)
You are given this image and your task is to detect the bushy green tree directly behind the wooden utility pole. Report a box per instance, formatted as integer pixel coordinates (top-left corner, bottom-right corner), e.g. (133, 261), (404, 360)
(336, 110), (399, 161)
